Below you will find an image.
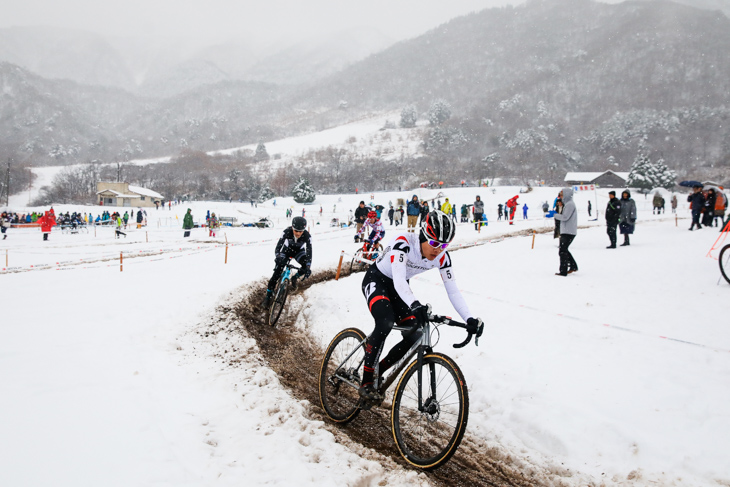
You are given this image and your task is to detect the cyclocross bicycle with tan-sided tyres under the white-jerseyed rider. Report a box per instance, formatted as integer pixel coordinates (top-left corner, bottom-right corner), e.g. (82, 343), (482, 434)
(319, 313), (484, 470)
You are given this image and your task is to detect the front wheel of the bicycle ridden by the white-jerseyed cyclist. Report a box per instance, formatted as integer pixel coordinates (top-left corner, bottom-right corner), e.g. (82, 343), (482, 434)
(391, 353), (469, 470)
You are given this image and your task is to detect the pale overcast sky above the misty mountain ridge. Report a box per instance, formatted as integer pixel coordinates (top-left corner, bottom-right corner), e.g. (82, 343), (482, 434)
(0, 0), (521, 45)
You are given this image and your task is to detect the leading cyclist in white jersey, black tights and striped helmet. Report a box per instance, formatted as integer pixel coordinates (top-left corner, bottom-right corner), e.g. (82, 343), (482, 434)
(359, 211), (482, 401)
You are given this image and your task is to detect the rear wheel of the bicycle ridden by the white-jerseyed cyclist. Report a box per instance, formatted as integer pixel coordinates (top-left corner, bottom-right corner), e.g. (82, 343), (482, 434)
(319, 328), (365, 423)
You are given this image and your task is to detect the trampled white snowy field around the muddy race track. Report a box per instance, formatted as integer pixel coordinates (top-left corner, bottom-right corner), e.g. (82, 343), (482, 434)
(0, 187), (730, 486)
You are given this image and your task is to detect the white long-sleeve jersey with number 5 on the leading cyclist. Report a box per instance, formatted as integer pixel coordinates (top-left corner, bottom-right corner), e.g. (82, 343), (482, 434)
(375, 232), (473, 321)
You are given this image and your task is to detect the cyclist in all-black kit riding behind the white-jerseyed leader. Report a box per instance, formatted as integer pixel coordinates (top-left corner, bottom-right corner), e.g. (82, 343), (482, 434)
(263, 216), (312, 307)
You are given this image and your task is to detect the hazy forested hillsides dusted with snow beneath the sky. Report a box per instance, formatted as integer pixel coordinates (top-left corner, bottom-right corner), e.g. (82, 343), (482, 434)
(0, 0), (730, 189)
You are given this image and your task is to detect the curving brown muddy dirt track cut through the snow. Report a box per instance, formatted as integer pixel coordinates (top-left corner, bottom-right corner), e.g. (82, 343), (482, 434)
(209, 255), (571, 486)
